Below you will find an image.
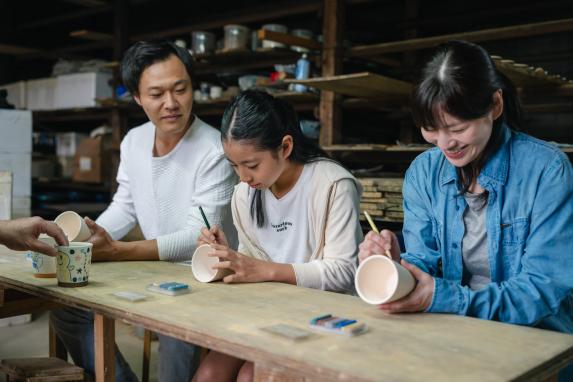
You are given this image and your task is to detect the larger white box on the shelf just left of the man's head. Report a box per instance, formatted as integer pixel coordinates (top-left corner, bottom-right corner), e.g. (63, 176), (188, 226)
(56, 72), (113, 109)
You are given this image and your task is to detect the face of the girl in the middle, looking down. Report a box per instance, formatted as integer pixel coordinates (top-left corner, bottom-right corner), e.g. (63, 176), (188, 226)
(219, 135), (293, 189)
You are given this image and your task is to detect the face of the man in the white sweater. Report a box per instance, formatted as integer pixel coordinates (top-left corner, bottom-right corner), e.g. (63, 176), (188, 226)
(134, 55), (193, 135)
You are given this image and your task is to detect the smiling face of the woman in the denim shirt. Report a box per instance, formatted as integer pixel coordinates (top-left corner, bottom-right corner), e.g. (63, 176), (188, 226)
(422, 91), (503, 167)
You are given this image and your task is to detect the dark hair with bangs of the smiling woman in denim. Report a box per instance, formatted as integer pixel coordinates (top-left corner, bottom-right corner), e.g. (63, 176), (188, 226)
(412, 41), (522, 198)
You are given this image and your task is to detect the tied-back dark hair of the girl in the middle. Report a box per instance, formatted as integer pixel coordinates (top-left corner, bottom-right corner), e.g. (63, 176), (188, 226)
(221, 90), (329, 227)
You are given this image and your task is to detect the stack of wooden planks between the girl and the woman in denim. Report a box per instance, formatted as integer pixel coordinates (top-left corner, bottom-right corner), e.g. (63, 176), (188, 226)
(358, 178), (404, 222)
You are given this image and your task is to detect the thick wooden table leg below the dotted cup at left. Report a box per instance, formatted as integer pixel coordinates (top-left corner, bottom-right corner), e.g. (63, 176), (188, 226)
(94, 313), (115, 382)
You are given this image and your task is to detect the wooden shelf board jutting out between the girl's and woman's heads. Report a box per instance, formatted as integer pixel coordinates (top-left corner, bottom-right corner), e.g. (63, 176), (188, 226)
(285, 72), (412, 100)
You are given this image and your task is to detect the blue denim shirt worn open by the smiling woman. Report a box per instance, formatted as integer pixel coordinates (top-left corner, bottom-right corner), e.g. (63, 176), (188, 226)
(402, 126), (573, 333)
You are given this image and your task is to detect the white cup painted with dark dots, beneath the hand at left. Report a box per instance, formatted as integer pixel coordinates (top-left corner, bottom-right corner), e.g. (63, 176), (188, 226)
(56, 242), (93, 288)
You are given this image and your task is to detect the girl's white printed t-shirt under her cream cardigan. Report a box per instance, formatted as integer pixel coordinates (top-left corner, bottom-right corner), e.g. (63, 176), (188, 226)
(255, 166), (316, 264)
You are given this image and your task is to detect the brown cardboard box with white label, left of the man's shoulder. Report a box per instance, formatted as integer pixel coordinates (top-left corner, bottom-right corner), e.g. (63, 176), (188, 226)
(73, 134), (111, 183)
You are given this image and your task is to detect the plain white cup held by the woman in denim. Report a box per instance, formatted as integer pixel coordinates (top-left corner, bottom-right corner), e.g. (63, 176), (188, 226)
(354, 255), (416, 305)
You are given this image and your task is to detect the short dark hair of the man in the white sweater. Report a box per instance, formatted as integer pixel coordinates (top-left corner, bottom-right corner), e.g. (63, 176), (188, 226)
(121, 41), (193, 94)
